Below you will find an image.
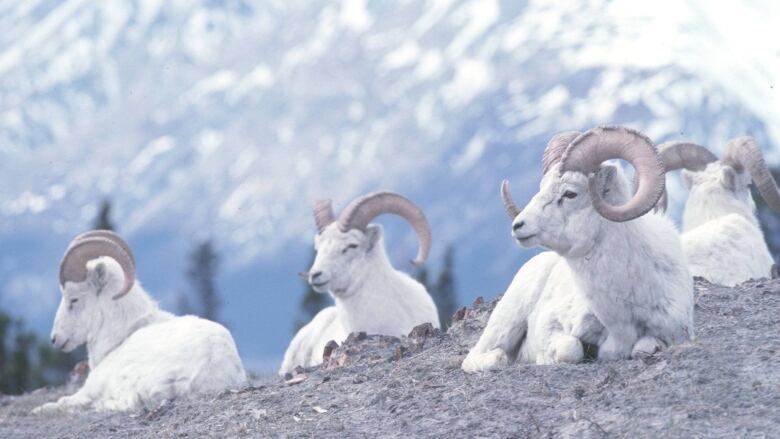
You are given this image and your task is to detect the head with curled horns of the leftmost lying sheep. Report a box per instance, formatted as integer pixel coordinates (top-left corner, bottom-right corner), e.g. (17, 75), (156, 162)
(51, 230), (135, 352)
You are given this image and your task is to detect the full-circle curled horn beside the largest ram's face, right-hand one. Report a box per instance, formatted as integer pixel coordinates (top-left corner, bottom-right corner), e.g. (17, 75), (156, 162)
(560, 126), (665, 222)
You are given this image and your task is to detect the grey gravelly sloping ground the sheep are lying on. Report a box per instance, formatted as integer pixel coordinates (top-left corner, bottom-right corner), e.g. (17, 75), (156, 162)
(0, 280), (780, 438)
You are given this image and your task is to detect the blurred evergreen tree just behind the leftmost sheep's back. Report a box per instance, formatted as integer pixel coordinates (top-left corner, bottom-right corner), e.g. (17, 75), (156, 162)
(187, 239), (222, 322)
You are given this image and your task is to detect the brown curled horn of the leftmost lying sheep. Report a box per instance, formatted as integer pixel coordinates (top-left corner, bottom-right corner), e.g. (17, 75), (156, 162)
(60, 231), (135, 300)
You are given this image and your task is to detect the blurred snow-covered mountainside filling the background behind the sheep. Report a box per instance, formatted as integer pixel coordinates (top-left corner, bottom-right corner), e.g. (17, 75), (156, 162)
(0, 0), (780, 372)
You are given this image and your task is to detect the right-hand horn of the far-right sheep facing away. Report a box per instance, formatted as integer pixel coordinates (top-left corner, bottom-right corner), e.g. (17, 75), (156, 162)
(721, 136), (780, 212)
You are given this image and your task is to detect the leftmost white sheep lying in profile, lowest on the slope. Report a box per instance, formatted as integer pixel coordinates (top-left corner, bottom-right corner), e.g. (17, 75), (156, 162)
(34, 231), (246, 413)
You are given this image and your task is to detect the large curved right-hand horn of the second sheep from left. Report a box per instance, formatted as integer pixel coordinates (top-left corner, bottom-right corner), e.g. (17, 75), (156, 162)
(339, 192), (431, 266)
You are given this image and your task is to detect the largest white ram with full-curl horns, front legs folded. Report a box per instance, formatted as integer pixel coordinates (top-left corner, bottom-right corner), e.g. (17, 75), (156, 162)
(462, 127), (694, 372)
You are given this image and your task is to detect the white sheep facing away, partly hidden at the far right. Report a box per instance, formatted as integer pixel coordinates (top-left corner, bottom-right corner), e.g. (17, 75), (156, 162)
(660, 136), (780, 286)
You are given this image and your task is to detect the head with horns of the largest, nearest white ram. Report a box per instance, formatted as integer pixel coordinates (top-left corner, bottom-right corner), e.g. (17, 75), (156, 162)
(501, 126), (664, 256)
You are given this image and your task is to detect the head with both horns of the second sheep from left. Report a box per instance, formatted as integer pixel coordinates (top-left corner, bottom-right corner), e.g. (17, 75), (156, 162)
(308, 192), (431, 295)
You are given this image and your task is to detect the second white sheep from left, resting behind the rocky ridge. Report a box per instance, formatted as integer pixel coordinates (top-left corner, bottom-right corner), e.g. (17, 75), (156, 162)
(279, 192), (439, 375)
